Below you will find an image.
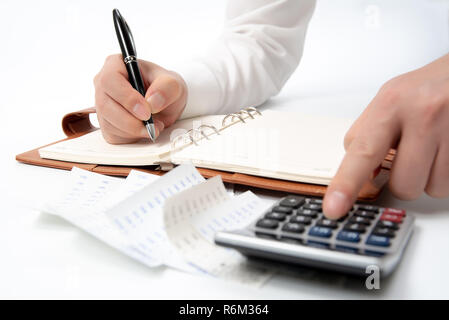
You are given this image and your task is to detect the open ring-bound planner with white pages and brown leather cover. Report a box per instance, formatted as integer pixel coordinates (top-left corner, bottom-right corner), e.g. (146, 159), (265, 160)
(17, 108), (391, 200)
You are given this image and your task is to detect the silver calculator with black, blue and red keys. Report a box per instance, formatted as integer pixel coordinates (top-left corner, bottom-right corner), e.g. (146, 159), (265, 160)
(215, 195), (414, 277)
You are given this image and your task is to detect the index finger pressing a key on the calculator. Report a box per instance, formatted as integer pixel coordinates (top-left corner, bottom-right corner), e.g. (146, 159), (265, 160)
(323, 117), (398, 219)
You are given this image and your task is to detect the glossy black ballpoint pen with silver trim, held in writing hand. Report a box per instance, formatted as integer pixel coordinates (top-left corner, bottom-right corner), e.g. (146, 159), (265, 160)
(112, 9), (156, 142)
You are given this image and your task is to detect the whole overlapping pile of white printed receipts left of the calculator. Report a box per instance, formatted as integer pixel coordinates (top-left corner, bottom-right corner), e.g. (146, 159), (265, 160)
(43, 165), (271, 285)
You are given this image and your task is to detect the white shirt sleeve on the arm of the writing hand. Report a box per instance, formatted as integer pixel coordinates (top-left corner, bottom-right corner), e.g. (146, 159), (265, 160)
(175, 0), (315, 118)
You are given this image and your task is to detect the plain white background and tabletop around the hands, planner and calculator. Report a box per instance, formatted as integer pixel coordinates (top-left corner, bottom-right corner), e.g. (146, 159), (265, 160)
(0, 0), (449, 299)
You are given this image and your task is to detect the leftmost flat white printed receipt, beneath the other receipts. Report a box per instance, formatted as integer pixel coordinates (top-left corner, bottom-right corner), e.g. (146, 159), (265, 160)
(42, 167), (159, 266)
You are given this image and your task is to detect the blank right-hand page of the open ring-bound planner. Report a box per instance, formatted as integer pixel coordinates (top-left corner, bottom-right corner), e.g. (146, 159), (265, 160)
(172, 111), (352, 185)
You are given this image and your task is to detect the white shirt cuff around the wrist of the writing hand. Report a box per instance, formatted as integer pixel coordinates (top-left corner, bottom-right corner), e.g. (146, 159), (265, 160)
(174, 61), (222, 119)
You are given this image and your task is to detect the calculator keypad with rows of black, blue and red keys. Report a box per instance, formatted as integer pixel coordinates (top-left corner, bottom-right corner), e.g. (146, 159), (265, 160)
(253, 196), (406, 256)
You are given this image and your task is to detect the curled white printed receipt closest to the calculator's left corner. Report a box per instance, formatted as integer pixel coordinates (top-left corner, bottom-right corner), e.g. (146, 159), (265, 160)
(164, 176), (272, 284)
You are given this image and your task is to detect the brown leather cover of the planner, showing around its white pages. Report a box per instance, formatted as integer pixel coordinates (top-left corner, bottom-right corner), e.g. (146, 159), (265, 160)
(16, 108), (394, 201)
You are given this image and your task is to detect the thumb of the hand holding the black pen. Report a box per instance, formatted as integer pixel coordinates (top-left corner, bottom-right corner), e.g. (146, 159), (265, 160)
(145, 73), (183, 113)
